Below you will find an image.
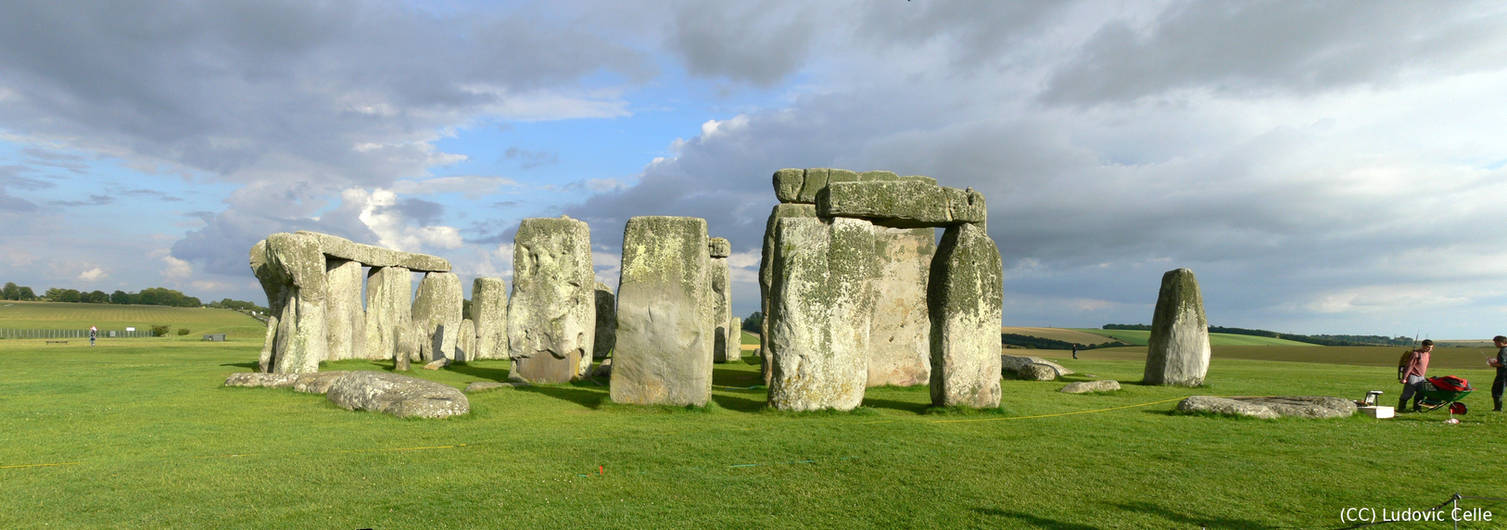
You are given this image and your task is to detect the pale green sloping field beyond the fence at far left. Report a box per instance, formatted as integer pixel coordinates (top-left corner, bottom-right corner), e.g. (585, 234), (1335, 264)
(0, 301), (267, 342)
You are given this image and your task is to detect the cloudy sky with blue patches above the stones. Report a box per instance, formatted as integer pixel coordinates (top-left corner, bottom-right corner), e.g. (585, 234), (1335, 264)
(0, 0), (1507, 339)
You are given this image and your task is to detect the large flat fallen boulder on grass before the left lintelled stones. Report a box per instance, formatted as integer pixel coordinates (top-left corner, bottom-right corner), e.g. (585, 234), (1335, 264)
(326, 372), (470, 417)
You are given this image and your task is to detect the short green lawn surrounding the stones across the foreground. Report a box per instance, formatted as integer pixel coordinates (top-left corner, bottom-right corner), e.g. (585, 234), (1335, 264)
(0, 339), (1507, 528)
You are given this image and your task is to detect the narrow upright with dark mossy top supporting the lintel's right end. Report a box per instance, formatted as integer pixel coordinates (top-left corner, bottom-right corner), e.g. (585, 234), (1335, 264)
(927, 224), (1004, 408)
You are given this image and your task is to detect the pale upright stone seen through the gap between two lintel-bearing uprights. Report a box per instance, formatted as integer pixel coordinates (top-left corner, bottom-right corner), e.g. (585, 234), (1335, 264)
(864, 225), (936, 387)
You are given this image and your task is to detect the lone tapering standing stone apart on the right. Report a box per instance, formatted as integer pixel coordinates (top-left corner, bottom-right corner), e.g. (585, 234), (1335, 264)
(1145, 268), (1210, 387)
